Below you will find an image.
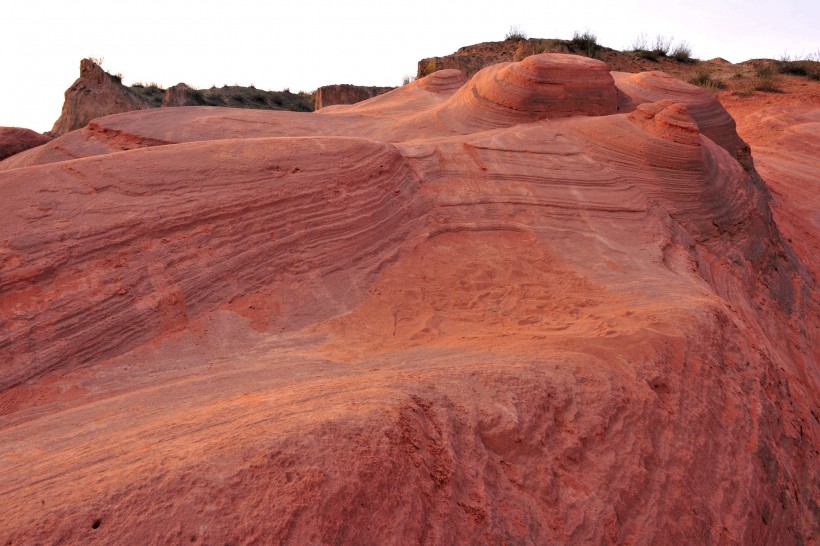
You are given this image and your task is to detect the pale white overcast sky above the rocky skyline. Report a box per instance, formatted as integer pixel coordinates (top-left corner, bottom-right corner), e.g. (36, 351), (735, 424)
(0, 0), (820, 131)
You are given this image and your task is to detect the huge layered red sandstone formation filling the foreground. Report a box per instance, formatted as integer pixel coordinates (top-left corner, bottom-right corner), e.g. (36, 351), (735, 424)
(0, 55), (820, 545)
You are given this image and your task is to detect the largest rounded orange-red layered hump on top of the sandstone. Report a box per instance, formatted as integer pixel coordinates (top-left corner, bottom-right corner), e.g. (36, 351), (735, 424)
(438, 53), (618, 131)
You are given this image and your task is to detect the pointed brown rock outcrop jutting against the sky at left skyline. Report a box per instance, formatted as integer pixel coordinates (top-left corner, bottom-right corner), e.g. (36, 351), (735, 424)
(51, 59), (151, 136)
